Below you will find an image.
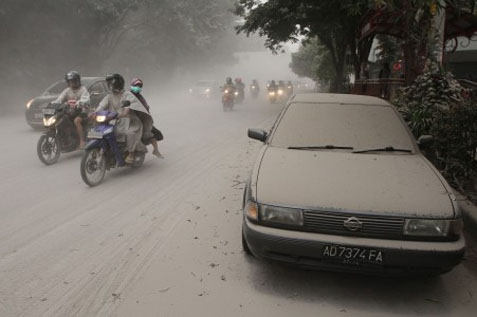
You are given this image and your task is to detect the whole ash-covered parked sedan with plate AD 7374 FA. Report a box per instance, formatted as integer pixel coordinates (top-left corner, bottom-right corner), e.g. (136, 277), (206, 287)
(242, 94), (465, 274)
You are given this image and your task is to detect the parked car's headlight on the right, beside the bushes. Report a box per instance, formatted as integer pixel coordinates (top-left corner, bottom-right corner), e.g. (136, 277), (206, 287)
(404, 219), (464, 237)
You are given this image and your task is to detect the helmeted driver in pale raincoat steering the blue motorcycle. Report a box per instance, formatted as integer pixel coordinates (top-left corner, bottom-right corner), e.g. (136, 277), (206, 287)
(92, 74), (145, 164)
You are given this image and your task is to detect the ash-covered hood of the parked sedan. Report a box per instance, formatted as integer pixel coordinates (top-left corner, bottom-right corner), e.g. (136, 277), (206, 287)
(257, 147), (454, 218)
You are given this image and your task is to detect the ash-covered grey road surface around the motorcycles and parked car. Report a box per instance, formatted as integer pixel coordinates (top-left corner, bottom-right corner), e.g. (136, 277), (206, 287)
(0, 92), (477, 316)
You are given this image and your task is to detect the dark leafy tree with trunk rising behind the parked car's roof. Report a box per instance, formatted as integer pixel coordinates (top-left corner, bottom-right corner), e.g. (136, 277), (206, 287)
(236, 0), (370, 91)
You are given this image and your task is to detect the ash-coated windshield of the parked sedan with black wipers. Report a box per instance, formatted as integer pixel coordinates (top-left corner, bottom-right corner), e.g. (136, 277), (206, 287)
(271, 103), (414, 154)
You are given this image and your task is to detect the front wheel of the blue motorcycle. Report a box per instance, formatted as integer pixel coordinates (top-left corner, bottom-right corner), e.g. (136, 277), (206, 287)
(81, 148), (106, 187)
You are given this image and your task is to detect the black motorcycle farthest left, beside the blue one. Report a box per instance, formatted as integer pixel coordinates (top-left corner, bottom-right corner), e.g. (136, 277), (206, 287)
(36, 103), (88, 165)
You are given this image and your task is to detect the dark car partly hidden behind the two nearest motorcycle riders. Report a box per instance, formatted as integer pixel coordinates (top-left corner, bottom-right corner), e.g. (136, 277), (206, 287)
(25, 77), (109, 128)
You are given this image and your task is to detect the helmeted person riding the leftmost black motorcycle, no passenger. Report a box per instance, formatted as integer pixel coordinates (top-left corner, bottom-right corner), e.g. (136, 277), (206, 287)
(53, 70), (90, 149)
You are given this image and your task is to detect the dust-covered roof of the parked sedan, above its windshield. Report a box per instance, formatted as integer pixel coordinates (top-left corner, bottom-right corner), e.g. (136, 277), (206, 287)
(291, 93), (392, 107)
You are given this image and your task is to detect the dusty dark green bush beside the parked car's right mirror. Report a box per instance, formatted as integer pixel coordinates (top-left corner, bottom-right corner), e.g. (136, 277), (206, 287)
(393, 71), (477, 190)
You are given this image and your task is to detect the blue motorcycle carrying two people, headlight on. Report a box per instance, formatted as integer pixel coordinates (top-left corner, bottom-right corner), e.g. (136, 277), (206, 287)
(80, 105), (150, 187)
